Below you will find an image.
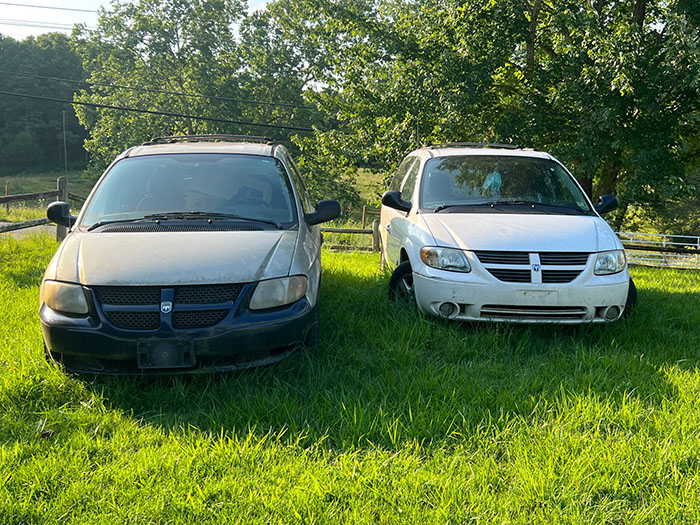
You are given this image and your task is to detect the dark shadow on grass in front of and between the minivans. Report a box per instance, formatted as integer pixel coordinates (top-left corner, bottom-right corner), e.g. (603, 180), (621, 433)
(83, 268), (700, 448)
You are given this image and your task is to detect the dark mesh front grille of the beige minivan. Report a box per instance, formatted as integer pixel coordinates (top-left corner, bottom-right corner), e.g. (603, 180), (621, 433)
(94, 284), (244, 330)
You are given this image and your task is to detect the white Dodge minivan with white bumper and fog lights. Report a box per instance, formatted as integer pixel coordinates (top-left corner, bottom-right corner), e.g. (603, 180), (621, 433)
(380, 143), (637, 324)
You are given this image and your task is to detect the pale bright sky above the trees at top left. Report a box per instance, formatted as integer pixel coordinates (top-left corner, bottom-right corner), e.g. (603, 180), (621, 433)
(0, 0), (268, 40)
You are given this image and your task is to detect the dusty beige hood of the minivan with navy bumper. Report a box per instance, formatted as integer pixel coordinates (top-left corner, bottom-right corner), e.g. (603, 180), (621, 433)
(46, 230), (297, 286)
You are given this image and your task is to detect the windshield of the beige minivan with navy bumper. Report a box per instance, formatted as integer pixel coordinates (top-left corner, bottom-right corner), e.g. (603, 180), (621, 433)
(81, 153), (296, 227)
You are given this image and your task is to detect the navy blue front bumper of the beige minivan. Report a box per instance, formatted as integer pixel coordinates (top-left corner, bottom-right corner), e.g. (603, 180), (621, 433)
(39, 298), (318, 376)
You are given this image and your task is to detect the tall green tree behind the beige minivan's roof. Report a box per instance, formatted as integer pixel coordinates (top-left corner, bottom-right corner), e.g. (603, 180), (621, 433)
(73, 0), (243, 172)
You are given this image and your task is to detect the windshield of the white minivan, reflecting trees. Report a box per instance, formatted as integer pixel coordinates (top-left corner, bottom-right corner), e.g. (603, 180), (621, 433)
(421, 155), (591, 212)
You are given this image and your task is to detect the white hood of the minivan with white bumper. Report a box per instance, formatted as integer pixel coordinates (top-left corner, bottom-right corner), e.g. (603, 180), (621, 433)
(422, 213), (622, 252)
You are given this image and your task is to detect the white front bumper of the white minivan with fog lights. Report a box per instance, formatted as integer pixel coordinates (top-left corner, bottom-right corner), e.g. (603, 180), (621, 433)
(413, 271), (629, 324)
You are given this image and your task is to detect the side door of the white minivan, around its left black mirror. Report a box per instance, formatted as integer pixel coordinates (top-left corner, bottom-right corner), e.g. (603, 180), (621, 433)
(380, 157), (420, 265)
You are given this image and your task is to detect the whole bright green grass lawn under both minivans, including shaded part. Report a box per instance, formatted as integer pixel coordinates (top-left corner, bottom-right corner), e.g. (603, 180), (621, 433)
(0, 235), (700, 524)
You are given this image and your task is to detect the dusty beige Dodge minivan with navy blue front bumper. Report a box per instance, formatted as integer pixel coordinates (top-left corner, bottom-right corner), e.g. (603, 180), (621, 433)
(40, 135), (340, 375)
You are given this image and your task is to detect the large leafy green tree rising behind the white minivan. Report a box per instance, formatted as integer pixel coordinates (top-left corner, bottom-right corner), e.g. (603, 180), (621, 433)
(272, 0), (700, 223)
